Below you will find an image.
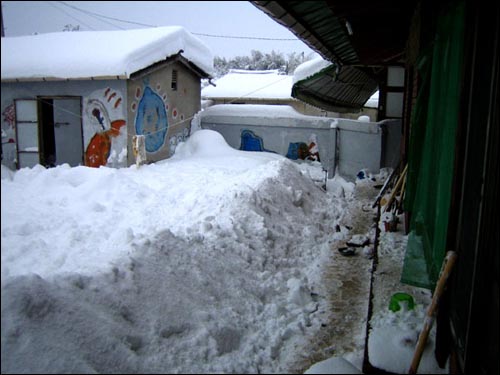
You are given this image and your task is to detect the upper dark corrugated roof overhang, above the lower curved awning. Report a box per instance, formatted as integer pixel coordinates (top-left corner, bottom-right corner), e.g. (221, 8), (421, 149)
(251, 0), (416, 66)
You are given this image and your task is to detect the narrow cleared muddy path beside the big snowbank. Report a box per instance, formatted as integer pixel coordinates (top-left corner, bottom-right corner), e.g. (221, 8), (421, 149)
(291, 180), (380, 373)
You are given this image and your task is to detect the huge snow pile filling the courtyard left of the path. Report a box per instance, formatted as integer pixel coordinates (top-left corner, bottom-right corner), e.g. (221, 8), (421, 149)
(1, 130), (340, 373)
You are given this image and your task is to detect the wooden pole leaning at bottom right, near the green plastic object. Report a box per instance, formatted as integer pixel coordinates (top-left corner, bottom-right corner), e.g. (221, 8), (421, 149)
(408, 251), (457, 374)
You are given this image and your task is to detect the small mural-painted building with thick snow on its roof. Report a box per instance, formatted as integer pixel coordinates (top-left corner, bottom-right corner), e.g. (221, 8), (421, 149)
(1, 26), (213, 169)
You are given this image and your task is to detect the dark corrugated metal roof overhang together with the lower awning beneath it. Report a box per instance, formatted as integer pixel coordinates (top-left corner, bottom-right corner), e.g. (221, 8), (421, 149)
(251, 0), (416, 112)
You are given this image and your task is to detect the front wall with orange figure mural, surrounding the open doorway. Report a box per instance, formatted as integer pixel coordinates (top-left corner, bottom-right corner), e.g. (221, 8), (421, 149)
(1, 80), (127, 169)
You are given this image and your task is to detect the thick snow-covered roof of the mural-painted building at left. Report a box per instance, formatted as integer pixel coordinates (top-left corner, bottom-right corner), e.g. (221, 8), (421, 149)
(1, 26), (213, 80)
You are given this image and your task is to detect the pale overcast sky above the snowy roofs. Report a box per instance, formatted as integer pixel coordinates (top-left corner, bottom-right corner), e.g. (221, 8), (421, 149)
(2, 1), (313, 58)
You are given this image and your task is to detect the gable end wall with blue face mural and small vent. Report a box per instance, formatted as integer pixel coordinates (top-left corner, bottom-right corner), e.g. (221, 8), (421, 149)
(127, 62), (201, 164)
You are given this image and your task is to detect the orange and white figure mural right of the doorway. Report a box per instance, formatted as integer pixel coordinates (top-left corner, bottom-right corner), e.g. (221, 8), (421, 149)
(83, 87), (127, 168)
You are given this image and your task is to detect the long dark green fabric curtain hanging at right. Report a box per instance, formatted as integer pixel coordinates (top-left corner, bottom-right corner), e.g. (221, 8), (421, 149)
(401, 2), (465, 289)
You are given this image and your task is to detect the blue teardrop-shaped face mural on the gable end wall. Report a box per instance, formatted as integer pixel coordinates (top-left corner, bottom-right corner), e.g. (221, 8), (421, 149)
(135, 87), (168, 152)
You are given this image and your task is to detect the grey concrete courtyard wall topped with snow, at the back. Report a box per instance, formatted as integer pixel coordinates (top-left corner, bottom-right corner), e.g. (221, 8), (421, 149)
(197, 104), (401, 180)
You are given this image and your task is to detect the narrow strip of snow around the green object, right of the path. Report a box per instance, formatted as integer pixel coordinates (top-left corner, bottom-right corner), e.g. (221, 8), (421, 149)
(368, 216), (449, 374)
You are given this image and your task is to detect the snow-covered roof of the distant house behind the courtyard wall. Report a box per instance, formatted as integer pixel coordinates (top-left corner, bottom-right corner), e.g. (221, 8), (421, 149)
(201, 69), (292, 100)
